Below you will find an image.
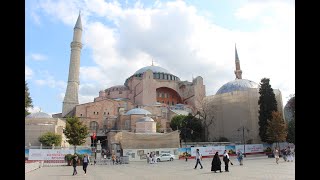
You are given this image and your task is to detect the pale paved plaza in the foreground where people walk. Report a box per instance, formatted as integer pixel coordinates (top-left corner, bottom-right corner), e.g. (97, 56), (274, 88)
(25, 156), (295, 180)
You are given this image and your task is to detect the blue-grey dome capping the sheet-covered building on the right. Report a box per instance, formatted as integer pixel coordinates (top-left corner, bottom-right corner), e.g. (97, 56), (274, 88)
(216, 79), (259, 94)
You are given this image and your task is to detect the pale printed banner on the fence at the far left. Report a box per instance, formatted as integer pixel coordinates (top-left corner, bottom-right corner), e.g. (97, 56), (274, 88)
(29, 149), (74, 160)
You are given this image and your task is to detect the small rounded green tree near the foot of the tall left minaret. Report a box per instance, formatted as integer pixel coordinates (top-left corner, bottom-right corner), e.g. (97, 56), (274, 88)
(63, 117), (89, 152)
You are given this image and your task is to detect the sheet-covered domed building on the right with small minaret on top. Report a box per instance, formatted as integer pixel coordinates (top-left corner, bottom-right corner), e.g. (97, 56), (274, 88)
(205, 48), (283, 143)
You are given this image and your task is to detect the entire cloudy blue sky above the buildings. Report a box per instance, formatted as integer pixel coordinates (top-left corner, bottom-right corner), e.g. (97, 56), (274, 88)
(25, 0), (295, 114)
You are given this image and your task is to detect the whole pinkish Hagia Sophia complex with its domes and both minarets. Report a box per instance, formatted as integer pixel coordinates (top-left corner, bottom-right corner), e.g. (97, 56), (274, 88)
(26, 14), (283, 149)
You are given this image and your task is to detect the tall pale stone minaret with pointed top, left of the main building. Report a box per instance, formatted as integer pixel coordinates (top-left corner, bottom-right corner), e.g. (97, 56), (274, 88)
(62, 13), (82, 117)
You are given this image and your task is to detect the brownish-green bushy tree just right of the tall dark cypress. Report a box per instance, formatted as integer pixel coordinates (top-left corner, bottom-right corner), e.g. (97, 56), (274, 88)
(266, 111), (287, 144)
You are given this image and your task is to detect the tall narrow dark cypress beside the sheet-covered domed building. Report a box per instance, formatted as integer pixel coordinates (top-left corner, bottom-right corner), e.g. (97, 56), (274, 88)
(258, 78), (277, 142)
